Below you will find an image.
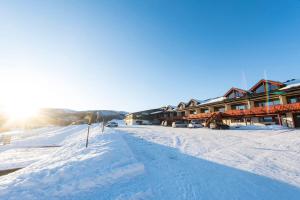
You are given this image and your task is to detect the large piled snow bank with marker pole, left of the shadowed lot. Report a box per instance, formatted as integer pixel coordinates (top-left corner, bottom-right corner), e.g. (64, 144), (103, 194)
(0, 127), (144, 200)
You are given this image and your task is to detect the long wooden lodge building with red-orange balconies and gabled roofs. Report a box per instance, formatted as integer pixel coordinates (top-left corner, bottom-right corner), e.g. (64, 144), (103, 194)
(125, 79), (300, 128)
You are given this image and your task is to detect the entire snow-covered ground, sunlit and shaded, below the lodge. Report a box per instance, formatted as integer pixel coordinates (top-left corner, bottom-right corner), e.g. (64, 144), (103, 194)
(0, 125), (300, 200)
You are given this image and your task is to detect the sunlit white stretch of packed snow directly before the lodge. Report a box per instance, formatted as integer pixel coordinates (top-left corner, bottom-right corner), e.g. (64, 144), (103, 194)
(120, 126), (300, 187)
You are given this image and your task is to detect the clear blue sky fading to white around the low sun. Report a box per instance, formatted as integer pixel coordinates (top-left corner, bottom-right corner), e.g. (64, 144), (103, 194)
(0, 0), (300, 111)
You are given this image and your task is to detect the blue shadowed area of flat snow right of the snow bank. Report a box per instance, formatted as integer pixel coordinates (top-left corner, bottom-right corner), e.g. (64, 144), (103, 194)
(76, 132), (300, 200)
